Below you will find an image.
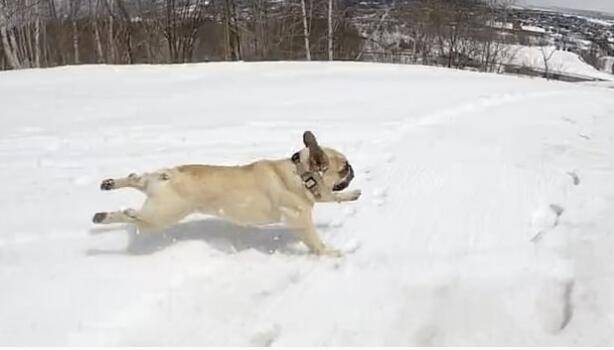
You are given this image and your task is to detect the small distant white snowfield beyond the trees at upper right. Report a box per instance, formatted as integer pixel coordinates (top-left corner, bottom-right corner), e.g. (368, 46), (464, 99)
(505, 45), (614, 80)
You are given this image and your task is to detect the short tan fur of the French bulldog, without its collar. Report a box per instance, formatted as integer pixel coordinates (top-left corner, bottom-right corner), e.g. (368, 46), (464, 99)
(93, 132), (360, 255)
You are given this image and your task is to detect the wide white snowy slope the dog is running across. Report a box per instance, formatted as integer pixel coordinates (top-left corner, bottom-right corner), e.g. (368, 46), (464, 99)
(0, 63), (614, 345)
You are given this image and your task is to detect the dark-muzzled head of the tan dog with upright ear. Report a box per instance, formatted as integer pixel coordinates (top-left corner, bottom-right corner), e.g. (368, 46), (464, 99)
(300, 131), (354, 191)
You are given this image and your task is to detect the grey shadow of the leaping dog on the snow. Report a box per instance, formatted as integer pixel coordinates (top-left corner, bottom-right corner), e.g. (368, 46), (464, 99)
(86, 218), (327, 256)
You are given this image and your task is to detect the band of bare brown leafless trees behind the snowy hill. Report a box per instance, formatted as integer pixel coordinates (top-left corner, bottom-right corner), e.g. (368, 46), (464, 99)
(0, 0), (516, 71)
